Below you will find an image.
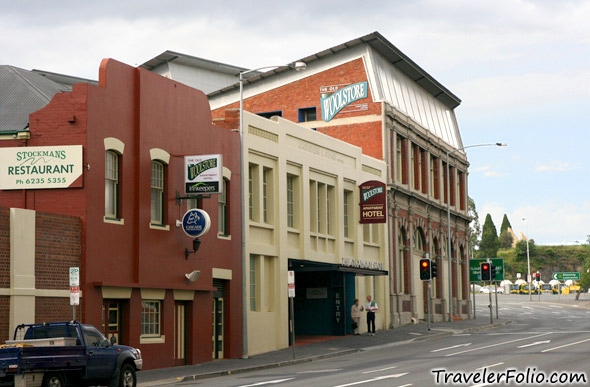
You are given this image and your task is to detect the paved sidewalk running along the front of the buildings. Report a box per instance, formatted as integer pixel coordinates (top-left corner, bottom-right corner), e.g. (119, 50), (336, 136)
(137, 316), (510, 387)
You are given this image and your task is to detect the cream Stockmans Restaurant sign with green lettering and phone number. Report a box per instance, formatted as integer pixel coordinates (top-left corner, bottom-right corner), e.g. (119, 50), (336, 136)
(0, 145), (82, 190)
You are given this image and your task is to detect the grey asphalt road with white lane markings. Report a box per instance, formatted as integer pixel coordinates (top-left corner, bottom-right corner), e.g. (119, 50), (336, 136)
(176, 295), (590, 387)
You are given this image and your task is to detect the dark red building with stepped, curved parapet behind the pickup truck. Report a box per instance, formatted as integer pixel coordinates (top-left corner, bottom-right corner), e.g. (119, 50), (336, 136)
(0, 60), (242, 369)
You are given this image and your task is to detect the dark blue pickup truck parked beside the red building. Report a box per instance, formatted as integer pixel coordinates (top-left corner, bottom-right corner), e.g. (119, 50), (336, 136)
(0, 321), (143, 387)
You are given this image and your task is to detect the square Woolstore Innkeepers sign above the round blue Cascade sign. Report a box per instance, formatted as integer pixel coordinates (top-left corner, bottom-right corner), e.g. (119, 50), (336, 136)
(184, 155), (223, 194)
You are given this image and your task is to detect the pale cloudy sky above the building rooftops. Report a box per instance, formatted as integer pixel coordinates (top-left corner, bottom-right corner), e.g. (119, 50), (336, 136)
(0, 0), (590, 244)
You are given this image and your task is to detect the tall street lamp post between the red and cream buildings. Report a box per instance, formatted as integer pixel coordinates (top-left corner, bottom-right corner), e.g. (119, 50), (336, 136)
(239, 62), (307, 359)
